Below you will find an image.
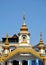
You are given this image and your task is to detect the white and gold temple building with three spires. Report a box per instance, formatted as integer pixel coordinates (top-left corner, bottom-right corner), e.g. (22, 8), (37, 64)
(0, 17), (46, 65)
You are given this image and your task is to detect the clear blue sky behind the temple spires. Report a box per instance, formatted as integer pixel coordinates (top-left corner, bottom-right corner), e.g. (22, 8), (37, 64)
(0, 0), (46, 45)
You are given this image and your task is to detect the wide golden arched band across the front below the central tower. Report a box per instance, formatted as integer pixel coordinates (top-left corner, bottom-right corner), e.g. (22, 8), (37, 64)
(0, 47), (46, 62)
